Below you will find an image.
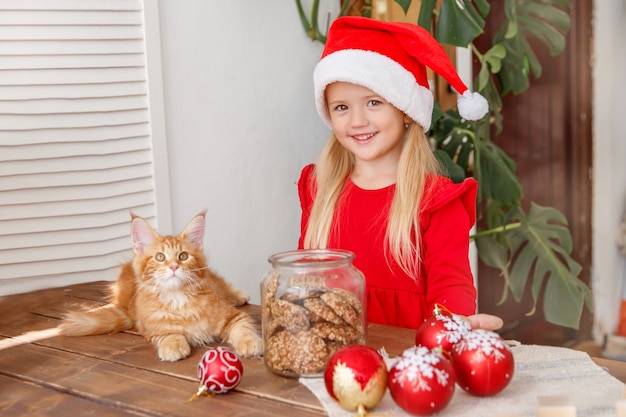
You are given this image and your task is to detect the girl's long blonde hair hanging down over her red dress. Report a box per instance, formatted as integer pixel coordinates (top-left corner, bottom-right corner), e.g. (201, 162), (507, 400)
(304, 123), (441, 277)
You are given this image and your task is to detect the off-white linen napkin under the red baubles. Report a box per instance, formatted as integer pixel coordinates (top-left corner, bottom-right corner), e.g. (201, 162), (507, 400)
(300, 345), (624, 417)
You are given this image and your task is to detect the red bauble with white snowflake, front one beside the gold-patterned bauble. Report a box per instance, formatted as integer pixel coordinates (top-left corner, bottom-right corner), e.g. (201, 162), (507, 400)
(389, 346), (456, 416)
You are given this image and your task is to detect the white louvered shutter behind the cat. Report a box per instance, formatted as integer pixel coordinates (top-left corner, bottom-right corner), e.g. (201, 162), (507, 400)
(0, 0), (168, 295)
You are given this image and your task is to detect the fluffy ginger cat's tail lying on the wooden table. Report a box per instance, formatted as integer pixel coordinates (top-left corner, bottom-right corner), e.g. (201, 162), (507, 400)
(57, 304), (133, 336)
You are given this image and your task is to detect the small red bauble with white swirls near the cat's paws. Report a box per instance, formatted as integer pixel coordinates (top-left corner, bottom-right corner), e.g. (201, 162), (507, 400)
(198, 346), (243, 394)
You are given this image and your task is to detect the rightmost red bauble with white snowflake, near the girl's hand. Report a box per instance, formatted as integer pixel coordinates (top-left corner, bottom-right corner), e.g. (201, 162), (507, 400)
(452, 329), (515, 396)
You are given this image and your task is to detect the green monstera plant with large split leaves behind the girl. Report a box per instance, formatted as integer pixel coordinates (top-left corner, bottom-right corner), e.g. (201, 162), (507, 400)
(296, 0), (592, 329)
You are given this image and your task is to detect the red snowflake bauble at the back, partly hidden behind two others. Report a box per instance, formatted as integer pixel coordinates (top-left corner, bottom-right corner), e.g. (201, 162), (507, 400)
(415, 305), (471, 354)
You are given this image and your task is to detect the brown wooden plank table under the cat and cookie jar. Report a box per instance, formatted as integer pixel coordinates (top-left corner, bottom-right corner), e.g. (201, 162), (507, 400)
(0, 282), (626, 417)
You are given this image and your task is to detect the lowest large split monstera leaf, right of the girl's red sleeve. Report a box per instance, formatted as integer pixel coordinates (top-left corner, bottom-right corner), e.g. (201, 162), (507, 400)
(476, 203), (592, 329)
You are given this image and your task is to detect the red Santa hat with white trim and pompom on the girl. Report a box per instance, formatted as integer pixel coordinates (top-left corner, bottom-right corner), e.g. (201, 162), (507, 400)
(313, 16), (489, 130)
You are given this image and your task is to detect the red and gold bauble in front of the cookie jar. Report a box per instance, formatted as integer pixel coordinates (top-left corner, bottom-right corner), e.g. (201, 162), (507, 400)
(324, 345), (387, 415)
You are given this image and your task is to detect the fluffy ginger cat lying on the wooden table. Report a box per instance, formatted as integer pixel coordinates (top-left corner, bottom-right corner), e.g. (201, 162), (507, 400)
(59, 212), (263, 361)
